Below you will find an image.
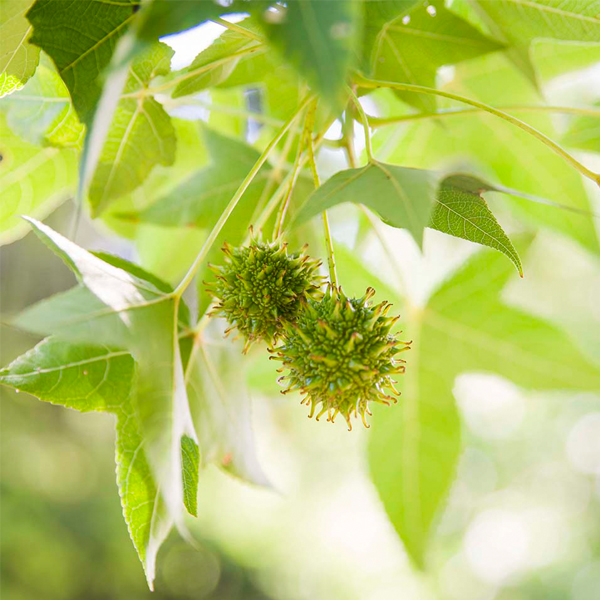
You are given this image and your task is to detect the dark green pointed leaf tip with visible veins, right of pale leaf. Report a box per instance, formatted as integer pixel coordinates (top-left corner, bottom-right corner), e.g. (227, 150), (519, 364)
(429, 175), (523, 277)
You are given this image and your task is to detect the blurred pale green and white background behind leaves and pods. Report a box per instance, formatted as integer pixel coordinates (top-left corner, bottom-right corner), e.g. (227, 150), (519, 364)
(0, 0), (600, 600)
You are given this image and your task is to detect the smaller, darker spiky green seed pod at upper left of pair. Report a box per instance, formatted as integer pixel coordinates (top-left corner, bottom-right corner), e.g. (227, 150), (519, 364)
(207, 238), (323, 352)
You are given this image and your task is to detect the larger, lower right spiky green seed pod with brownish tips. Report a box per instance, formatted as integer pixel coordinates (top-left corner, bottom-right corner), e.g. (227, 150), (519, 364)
(271, 288), (410, 429)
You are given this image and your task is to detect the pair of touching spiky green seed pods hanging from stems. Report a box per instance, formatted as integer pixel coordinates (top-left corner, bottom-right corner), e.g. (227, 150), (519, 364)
(208, 239), (410, 429)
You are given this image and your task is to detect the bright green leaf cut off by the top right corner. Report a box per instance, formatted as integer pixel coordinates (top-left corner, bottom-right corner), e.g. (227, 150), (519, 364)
(471, 0), (600, 82)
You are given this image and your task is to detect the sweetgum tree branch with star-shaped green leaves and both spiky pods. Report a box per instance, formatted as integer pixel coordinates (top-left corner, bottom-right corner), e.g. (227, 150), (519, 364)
(0, 0), (600, 588)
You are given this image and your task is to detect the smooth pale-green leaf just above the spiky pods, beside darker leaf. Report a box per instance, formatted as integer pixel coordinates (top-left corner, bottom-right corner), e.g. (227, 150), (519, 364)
(296, 161), (441, 245)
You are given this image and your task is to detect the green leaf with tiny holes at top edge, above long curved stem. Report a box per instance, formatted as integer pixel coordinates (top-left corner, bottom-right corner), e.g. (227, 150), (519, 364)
(371, 2), (503, 112)
